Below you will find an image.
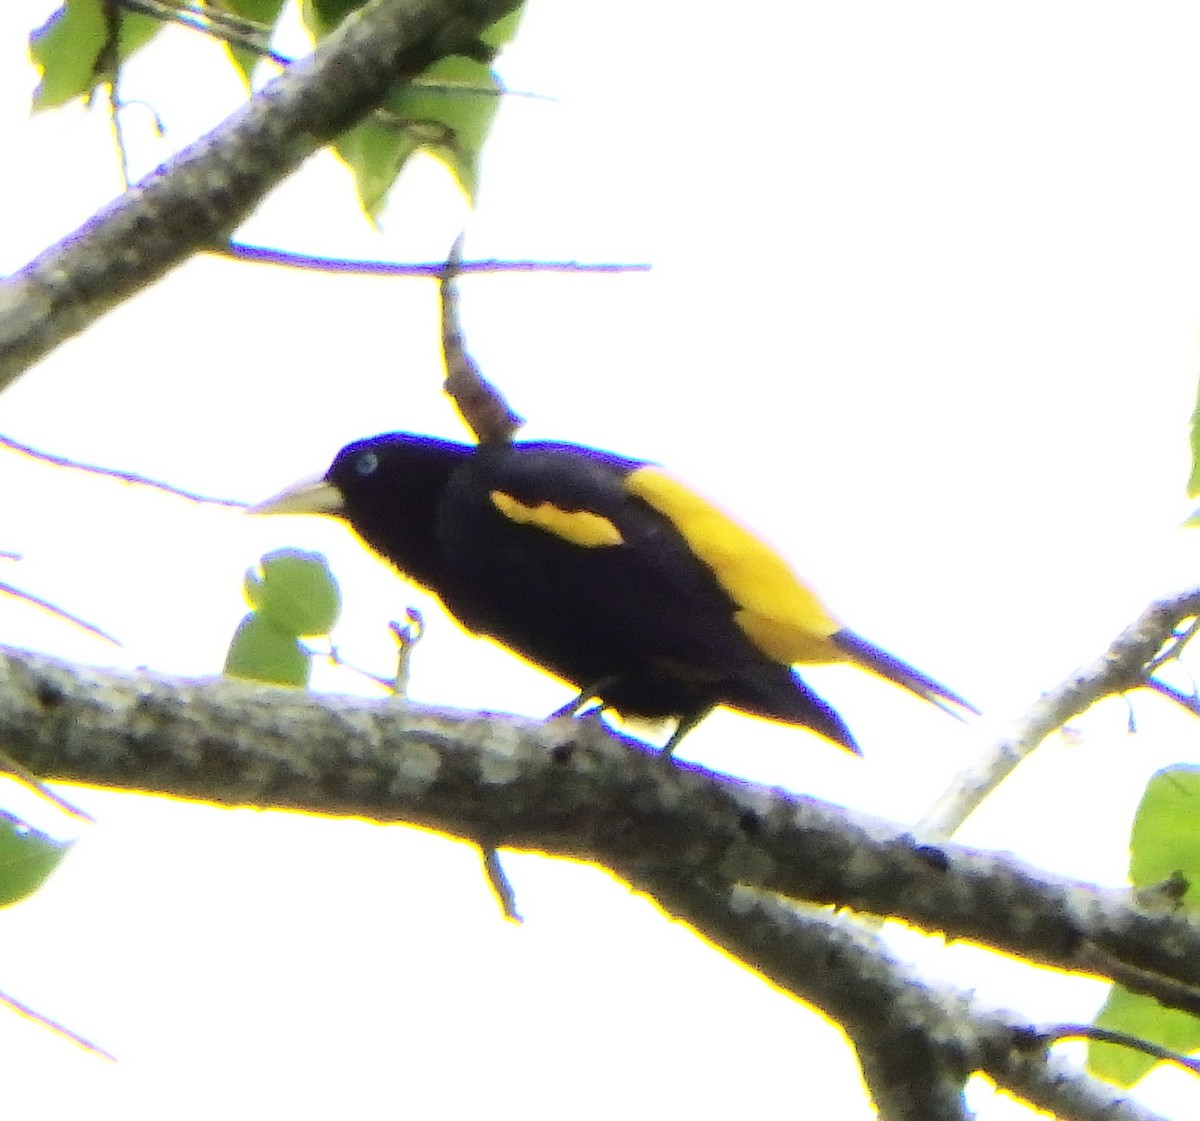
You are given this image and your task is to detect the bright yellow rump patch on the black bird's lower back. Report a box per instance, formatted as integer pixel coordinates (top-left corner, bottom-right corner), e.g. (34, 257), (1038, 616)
(625, 467), (846, 665)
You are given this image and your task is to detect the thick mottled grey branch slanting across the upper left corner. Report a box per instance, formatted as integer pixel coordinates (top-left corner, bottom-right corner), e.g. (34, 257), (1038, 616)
(0, 0), (516, 390)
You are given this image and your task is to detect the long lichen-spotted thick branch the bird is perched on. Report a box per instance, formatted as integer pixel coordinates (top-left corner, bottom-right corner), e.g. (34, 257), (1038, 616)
(0, 651), (1200, 1007)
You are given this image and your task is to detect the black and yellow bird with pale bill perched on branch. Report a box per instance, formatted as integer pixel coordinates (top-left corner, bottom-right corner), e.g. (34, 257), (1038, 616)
(252, 432), (976, 751)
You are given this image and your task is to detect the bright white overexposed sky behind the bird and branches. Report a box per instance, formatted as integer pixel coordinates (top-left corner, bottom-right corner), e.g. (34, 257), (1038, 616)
(0, 0), (1200, 1121)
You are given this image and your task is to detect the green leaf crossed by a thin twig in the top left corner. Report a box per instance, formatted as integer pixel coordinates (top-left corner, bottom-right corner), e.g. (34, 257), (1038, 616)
(29, 0), (162, 110)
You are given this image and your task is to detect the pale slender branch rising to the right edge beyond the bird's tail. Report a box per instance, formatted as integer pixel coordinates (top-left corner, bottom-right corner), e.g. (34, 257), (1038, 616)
(914, 589), (1200, 841)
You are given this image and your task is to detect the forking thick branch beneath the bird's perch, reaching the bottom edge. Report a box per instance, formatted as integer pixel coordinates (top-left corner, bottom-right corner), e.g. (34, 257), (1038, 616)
(646, 879), (1157, 1121)
